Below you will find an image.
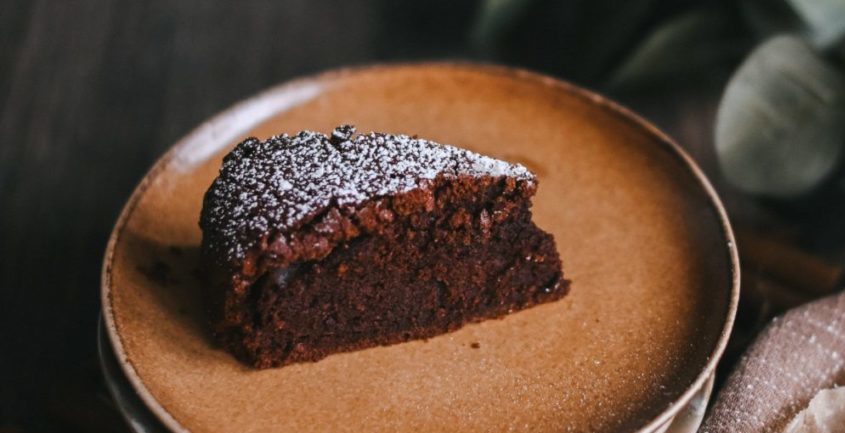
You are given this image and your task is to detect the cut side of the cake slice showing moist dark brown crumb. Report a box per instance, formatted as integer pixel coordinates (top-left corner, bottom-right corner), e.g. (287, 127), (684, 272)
(232, 174), (568, 367)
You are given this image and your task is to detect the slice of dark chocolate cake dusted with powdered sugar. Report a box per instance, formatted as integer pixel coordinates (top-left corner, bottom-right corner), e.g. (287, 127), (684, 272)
(200, 126), (569, 368)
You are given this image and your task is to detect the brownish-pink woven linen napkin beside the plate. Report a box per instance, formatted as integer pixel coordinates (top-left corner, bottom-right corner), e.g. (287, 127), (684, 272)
(700, 293), (845, 433)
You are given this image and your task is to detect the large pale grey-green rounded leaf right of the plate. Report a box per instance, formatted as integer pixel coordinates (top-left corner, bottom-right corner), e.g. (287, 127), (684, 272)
(715, 35), (845, 198)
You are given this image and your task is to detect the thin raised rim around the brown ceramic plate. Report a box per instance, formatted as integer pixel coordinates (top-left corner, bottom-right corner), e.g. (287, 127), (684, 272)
(100, 61), (740, 433)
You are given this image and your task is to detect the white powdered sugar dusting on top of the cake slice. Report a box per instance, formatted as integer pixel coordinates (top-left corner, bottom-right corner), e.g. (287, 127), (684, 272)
(200, 125), (534, 261)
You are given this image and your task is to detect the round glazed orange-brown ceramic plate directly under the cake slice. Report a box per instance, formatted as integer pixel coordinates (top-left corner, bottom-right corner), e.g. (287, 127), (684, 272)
(102, 64), (739, 433)
